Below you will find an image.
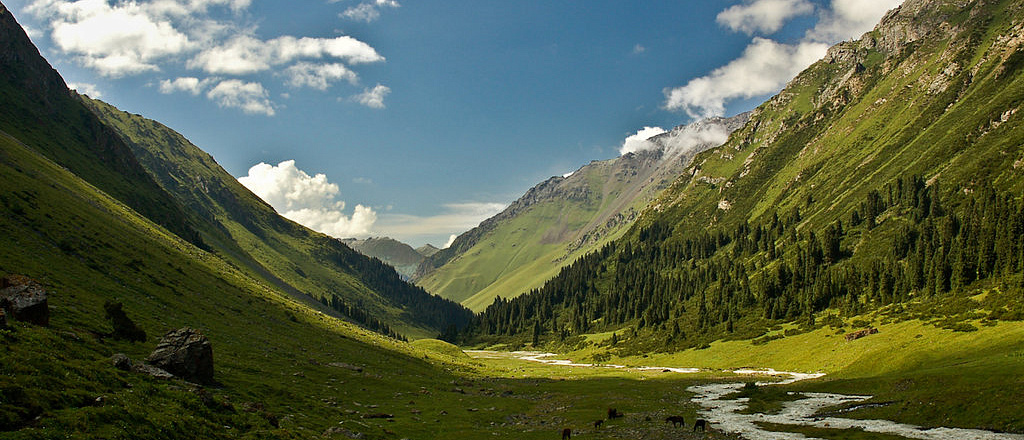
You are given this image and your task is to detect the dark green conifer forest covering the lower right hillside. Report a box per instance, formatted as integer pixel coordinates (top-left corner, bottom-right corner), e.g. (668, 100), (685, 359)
(465, 176), (1024, 350)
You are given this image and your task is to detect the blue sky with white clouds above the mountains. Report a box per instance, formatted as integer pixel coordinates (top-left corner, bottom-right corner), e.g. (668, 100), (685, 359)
(5, 0), (899, 246)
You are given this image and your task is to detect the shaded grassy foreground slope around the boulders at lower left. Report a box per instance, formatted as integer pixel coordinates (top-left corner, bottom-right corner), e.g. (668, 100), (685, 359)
(0, 115), (468, 439)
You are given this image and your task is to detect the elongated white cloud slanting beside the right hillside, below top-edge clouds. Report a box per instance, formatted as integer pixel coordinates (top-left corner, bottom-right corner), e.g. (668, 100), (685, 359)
(665, 37), (828, 118)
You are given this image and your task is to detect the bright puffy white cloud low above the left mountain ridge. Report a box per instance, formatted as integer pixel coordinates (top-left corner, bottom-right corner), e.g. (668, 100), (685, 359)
(239, 161), (377, 237)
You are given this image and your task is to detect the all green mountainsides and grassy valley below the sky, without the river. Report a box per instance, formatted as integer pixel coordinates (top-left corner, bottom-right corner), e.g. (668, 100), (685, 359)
(0, 0), (1024, 439)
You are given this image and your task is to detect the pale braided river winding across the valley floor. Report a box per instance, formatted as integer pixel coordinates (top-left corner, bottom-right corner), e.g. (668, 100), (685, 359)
(466, 350), (1024, 440)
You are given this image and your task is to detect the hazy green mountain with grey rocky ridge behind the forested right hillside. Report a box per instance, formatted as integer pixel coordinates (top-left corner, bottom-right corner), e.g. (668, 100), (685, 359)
(414, 114), (748, 310)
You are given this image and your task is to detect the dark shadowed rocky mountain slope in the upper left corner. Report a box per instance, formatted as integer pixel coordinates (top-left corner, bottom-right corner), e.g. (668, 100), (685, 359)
(0, 4), (202, 246)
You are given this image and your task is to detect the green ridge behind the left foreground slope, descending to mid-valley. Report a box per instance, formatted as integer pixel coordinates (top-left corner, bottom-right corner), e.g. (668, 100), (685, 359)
(82, 97), (469, 338)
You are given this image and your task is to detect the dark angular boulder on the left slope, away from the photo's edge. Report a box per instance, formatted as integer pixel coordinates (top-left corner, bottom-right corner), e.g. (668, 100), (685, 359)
(145, 327), (214, 384)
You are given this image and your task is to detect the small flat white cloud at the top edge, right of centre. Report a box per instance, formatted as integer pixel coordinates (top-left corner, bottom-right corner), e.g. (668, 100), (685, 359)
(715, 0), (814, 35)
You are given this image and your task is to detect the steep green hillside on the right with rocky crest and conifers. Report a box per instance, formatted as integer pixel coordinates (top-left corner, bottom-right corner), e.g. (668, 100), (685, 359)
(476, 1), (1024, 358)
